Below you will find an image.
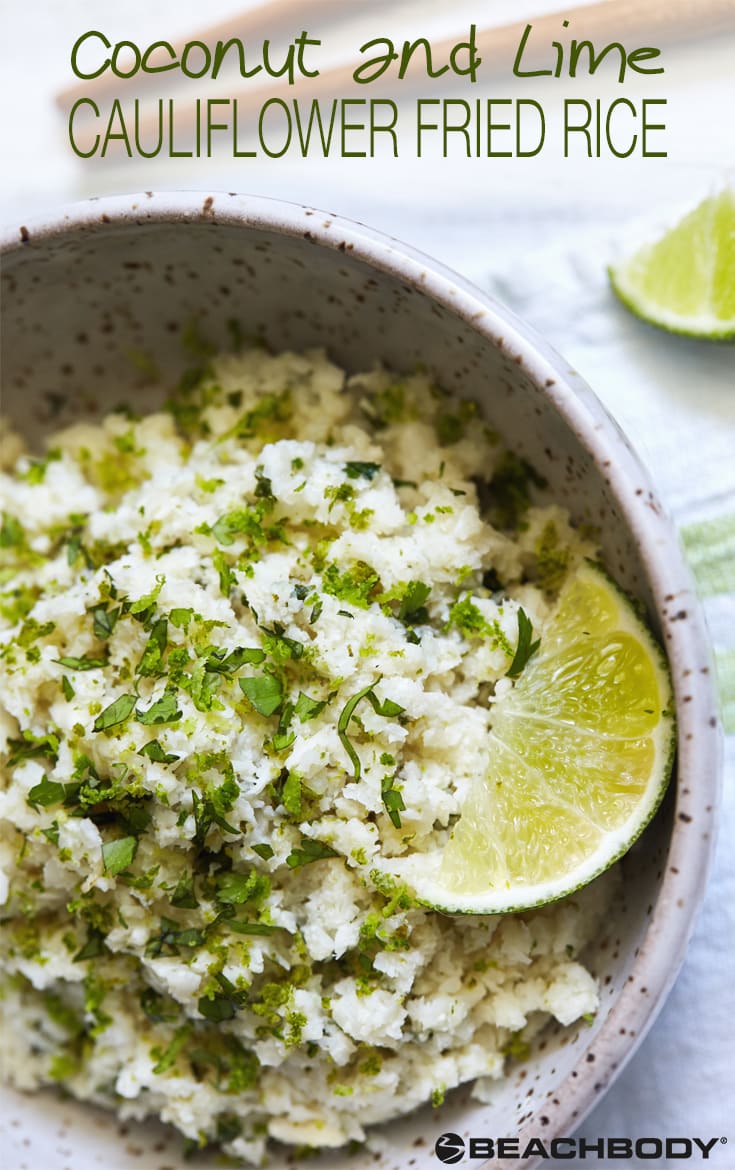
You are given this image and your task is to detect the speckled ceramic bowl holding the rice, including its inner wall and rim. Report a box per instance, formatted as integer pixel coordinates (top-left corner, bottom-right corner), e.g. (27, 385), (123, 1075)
(0, 193), (719, 1170)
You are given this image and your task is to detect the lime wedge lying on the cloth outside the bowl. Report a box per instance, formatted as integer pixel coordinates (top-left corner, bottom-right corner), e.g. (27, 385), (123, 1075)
(610, 188), (735, 339)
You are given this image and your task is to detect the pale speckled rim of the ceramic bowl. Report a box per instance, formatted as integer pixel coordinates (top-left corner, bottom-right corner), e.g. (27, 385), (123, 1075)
(0, 191), (722, 1170)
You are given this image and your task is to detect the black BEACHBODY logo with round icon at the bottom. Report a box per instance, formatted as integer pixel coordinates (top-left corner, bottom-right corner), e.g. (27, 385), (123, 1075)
(434, 1134), (727, 1165)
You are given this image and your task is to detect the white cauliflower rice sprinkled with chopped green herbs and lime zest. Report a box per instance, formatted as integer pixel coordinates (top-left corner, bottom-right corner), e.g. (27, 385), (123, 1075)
(0, 349), (609, 1163)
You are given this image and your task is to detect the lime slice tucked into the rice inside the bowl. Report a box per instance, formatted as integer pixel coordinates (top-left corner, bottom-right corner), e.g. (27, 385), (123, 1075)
(391, 564), (674, 914)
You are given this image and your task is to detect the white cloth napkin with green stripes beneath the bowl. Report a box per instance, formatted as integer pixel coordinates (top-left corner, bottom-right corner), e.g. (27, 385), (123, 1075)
(485, 230), (735, 1170)
